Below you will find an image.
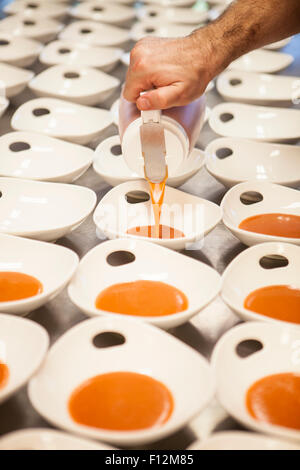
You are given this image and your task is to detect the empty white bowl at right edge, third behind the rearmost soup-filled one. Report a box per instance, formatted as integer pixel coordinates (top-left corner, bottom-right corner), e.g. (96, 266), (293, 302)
(217, 70), (300, 106)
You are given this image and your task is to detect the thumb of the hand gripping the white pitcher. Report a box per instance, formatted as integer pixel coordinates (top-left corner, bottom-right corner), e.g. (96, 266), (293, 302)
(136, 84), (183, 111)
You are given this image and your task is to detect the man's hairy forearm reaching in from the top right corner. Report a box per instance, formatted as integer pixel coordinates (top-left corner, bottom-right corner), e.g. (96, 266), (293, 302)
(192, 0), (300, 74)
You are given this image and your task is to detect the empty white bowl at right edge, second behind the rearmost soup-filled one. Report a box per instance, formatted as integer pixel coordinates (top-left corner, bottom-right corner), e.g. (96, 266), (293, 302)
(209, 103), (300, 142)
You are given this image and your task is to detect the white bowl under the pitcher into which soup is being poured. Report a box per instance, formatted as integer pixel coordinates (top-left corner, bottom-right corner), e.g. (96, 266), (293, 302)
(94, 180), (222, 250)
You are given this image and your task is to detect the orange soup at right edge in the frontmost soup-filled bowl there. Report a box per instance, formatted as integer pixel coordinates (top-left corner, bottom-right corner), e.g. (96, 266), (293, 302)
(246, 373), (300, 430)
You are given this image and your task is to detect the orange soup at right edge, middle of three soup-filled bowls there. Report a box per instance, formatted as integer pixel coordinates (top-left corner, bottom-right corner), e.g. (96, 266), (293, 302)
(244, 285), (300, 324)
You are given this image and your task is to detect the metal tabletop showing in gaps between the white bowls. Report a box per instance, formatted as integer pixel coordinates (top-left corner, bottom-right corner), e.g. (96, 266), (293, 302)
(0, 0), (300, 449)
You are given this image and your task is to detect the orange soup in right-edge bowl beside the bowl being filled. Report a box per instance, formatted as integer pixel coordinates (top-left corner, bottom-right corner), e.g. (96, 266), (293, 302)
(239, 214), (300, 238)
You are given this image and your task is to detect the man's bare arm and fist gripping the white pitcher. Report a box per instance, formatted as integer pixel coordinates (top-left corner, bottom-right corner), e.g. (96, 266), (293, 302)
(124, 0), (300, 110)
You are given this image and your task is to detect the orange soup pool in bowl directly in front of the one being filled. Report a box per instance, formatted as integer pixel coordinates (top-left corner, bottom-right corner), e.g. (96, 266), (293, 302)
(95, 281), (188, 317)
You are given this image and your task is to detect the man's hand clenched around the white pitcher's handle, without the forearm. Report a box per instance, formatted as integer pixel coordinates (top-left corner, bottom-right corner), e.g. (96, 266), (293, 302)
(123, 32), (215, 111)
